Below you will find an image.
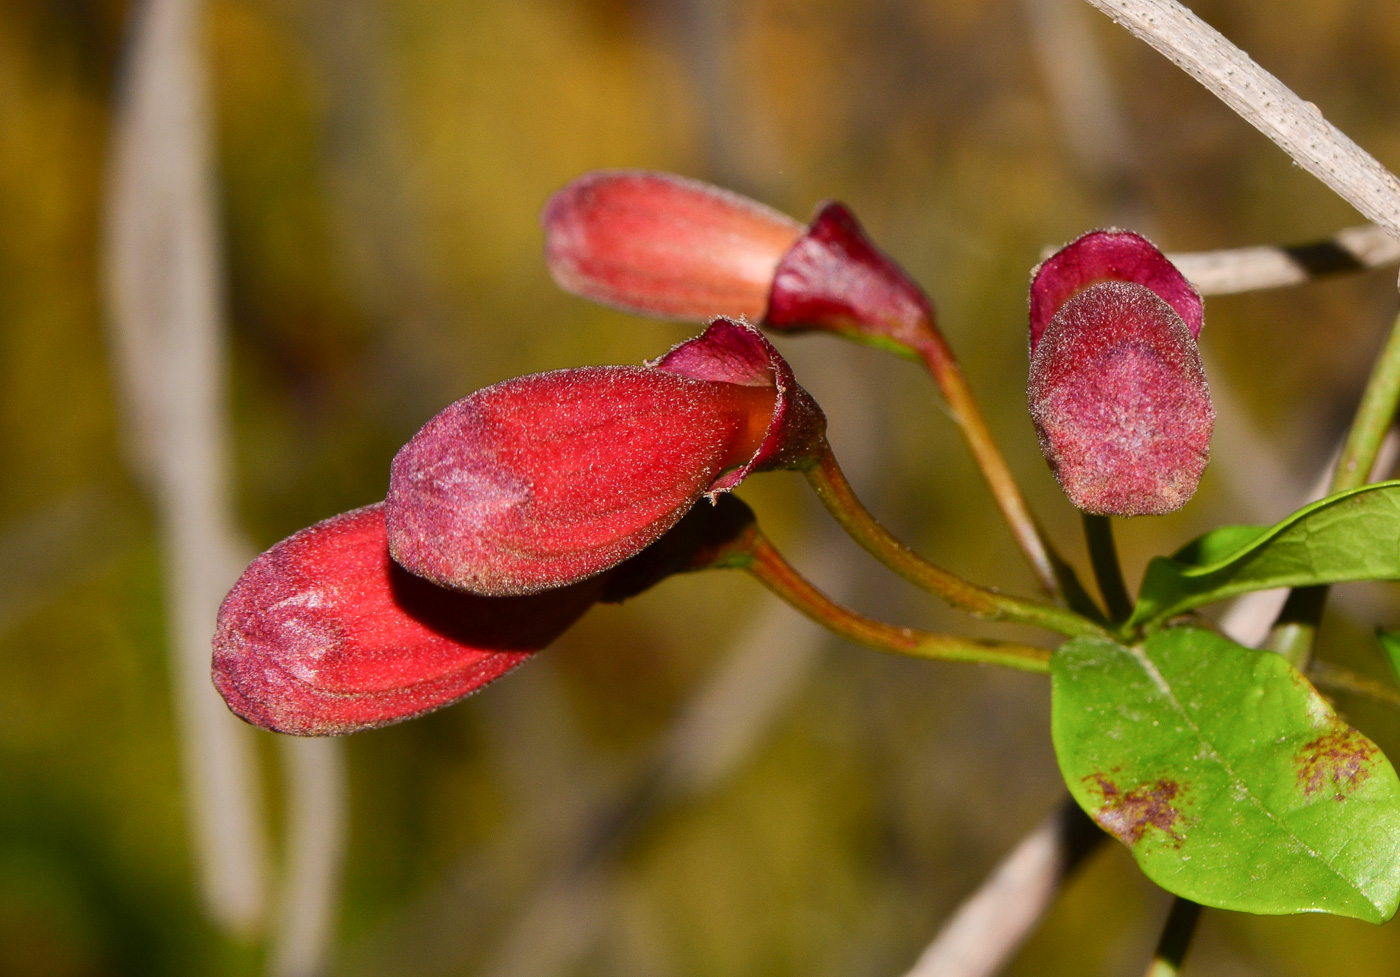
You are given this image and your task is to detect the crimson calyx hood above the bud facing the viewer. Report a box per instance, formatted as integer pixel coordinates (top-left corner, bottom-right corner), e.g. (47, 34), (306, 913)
(1030, 228), (1205, 353)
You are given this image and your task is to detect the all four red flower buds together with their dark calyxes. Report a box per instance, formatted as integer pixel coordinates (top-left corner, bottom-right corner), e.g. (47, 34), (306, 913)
(214, 171), (1214, 735)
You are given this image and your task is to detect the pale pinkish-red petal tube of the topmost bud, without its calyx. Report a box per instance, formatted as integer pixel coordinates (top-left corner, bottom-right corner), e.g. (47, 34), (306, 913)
(542, 169), (802, 321)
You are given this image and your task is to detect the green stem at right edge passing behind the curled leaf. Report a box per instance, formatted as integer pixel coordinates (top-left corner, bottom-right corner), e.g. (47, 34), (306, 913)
(1266, 307), (1400, 670)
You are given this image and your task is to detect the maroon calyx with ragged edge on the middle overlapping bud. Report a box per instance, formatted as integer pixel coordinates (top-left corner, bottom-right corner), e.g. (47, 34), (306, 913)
(651, 318), (826, 487)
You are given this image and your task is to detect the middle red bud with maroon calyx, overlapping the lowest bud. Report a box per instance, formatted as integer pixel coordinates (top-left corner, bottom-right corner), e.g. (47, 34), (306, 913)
(385, 319), (826, 596)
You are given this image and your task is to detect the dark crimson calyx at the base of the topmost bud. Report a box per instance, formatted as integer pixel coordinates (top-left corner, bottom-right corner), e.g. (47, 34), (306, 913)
(763, 202), (934, 350)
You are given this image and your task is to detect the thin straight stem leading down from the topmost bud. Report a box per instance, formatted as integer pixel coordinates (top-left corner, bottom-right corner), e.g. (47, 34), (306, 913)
(917, 333), (1064, 596)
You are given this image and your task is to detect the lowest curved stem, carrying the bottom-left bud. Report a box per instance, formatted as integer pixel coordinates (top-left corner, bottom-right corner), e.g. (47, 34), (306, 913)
(745, 533), (1050, 673)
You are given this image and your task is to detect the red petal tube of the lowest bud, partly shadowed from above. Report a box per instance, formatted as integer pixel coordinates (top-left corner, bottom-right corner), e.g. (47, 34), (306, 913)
(213, 505), (601, 736)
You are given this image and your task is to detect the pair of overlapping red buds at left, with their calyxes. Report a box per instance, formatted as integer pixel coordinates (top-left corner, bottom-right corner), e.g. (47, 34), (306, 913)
(214, 319), (826, 735)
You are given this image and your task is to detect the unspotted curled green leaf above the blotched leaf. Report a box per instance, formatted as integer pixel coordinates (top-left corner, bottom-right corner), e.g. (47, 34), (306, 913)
(1128, 482), (1400, 627)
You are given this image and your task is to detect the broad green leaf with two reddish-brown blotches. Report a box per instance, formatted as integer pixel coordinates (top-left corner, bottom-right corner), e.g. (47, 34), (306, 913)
(1050, 627), (1400, 922)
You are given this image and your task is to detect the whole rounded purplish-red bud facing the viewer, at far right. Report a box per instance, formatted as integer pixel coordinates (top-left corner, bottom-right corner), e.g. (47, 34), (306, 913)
(1028, 231), (1215, 515)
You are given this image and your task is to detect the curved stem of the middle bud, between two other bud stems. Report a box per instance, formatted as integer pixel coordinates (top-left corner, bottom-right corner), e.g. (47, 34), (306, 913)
(806, 448), (1105, 637)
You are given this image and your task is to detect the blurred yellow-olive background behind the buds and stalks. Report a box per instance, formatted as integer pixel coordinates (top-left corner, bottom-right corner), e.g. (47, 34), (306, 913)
(8, 0), (1400, 977)
